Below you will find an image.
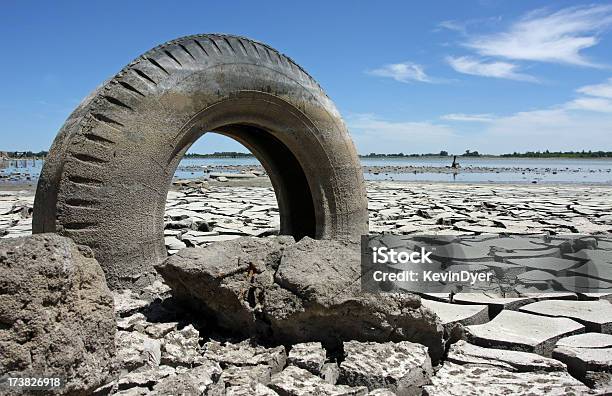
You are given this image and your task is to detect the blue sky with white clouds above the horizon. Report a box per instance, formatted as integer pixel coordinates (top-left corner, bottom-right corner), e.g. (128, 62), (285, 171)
(0, 0), (612, 153)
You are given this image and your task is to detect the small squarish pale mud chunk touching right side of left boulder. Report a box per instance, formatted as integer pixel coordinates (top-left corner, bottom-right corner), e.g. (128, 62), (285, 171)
(117, 331), (161, 371)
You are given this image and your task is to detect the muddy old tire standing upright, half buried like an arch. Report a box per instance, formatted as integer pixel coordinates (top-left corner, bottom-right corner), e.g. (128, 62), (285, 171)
(33, 34), (367, 288)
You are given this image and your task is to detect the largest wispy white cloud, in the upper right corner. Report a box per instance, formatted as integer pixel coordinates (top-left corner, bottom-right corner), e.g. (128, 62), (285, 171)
(465, 5), (612, 66)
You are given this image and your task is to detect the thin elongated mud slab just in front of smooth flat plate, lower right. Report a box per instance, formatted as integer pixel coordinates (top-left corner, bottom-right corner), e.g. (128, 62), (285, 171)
(447, 341), (565, 372)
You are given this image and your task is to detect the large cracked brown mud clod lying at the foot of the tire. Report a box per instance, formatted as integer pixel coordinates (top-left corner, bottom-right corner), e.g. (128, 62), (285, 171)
(156, 237), (443, 361)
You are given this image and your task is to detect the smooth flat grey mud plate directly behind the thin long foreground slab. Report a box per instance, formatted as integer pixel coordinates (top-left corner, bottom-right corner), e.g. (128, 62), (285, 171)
(465, 310), (584, 357)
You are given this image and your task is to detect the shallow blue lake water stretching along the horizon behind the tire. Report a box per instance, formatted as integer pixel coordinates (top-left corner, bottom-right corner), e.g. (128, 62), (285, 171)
(0, 157), (612, 184)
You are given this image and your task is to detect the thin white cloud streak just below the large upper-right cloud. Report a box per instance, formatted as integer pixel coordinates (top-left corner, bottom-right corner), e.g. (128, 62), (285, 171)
(446, 56), (537, 82)
